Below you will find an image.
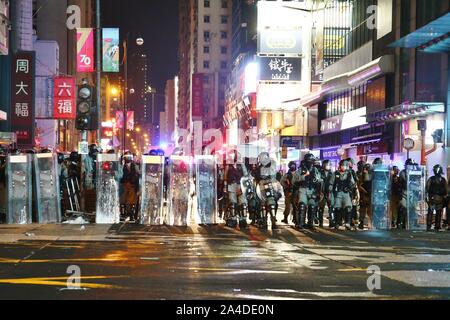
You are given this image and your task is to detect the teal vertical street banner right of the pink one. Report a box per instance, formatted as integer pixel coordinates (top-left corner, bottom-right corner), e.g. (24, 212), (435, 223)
(102, 28), (120, 72)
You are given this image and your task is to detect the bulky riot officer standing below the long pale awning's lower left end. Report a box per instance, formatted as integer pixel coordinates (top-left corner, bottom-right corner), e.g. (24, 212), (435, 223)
(294, 154), (322, 229)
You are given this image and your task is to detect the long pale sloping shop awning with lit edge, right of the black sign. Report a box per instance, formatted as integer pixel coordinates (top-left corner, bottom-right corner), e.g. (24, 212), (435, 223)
(299, 55), (394, 106)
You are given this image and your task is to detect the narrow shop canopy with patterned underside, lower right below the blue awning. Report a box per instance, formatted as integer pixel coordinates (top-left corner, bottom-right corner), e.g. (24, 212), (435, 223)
(368, 102), (445, 122)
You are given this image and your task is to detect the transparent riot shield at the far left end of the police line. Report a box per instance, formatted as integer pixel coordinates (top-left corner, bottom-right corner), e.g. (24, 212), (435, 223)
(7, 155), (33, 224)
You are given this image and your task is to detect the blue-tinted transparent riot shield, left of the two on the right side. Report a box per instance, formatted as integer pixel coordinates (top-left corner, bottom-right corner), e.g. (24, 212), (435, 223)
(372, 165), (391, 230)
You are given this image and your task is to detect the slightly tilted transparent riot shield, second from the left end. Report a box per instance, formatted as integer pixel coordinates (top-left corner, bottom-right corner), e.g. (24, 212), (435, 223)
(34, 153), (61, 224)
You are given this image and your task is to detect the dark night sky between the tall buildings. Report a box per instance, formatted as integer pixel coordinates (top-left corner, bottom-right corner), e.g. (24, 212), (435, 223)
(102, 0), (179, 93)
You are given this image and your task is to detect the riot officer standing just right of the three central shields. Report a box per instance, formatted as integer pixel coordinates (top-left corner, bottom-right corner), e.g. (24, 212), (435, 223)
(224, 150), (248, 228)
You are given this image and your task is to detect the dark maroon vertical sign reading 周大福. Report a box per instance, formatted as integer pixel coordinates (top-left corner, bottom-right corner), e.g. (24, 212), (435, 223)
(11, 52), (35, 147)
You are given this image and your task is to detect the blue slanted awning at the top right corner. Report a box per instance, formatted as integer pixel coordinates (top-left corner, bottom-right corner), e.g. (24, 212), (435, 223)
(389, 13), (450, 53)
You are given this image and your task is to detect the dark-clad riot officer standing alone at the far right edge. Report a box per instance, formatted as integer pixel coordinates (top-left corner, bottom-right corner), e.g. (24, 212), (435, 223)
(426, 164), (448, 231)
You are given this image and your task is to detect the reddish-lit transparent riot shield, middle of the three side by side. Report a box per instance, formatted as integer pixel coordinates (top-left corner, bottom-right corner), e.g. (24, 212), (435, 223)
(166, 156), (192, 226)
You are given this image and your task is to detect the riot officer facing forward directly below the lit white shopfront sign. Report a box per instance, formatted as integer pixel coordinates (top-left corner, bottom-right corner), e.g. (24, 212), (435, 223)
(330, 160), (358, 230)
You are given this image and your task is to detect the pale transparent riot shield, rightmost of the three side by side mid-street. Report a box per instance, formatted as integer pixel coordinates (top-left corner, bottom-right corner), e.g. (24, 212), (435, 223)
(195, 156), (219, 224)
